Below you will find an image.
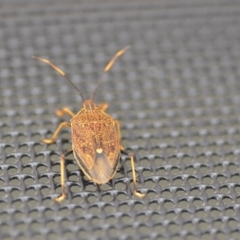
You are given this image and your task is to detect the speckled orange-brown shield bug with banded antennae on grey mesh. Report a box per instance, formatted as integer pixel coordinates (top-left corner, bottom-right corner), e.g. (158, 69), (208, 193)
(33, 46), (145, 202)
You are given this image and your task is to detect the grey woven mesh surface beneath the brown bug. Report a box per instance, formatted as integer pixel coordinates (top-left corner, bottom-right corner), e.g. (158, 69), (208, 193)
(0, 0), (240, 240)
